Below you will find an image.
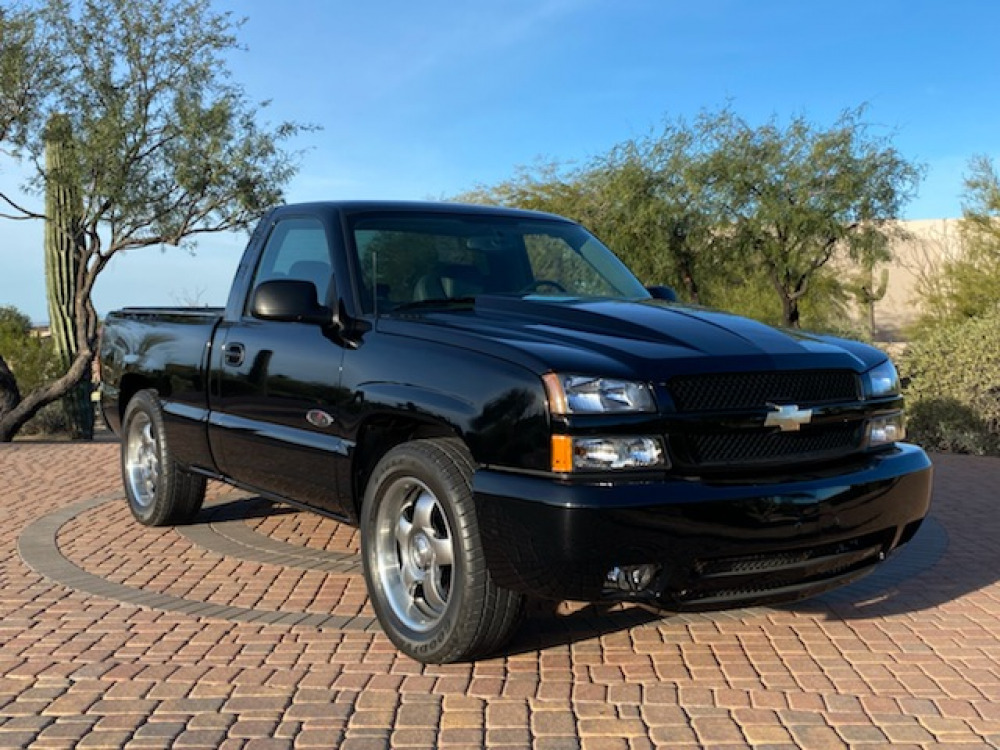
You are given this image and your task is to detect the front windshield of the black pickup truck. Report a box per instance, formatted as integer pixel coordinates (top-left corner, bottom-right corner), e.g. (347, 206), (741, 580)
(351, 214), (649, 313)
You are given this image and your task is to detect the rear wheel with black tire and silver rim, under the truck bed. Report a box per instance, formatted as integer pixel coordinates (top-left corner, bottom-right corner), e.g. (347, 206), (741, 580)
(121, 390), (205, 526)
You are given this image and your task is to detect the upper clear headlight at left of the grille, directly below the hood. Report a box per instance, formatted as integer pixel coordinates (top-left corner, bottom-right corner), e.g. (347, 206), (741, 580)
(542, 372), (656, 414)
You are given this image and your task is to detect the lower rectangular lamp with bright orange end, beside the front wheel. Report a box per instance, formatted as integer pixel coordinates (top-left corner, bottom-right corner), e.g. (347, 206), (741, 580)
(552, 435), (669, 473)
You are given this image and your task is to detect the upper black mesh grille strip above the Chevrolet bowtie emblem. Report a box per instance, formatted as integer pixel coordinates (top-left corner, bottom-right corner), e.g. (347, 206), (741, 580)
(667, 370), (861, 412)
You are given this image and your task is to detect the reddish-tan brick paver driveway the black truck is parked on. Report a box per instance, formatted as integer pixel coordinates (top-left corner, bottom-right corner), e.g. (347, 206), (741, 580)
(0, 442), (1000, 748)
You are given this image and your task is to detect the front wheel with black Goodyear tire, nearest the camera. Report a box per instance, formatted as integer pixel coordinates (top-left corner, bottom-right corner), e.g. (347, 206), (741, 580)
(361, 438), (524, 664)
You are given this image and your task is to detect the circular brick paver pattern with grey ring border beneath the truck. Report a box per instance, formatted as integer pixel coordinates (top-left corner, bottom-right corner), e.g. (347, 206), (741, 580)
(19, 494), (947, 631)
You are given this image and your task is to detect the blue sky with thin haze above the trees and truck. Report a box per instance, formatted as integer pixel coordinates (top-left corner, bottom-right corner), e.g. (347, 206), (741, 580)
(0, 0), (1000, 321)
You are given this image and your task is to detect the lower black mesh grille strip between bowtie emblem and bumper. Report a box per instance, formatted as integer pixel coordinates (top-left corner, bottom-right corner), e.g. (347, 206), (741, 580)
(671, 422), (864, 468)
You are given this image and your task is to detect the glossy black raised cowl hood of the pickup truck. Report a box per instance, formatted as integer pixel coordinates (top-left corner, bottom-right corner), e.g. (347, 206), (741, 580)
(379, 296), (885, 381)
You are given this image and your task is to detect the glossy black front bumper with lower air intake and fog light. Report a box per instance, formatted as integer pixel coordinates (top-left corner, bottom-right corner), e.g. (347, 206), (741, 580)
(473, 444), (932, 610)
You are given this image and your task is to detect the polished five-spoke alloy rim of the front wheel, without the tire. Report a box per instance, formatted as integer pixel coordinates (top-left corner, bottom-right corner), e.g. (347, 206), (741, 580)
(375, 477), (455, 632)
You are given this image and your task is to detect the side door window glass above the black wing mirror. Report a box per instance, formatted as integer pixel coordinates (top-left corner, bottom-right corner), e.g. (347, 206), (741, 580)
(244, 218), (333, 312)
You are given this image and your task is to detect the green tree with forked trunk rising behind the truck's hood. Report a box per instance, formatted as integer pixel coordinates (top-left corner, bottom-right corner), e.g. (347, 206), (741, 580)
(705, 109), (921, 328)
